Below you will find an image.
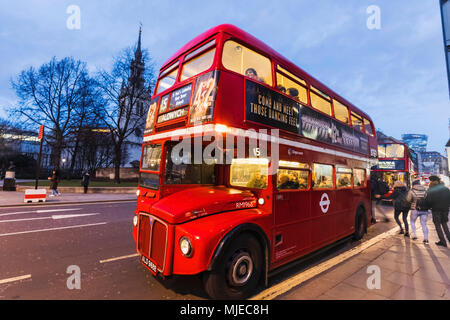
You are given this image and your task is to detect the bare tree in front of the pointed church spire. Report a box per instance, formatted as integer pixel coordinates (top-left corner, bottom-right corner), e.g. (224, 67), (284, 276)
(97, 46), (155, 183)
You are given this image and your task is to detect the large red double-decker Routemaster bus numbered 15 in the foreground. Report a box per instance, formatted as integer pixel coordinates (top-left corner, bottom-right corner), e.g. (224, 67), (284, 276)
(133, 25), (377, 299)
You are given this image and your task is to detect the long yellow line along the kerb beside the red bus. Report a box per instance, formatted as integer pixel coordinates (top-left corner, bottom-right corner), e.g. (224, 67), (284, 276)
(250, 227), (400, 300)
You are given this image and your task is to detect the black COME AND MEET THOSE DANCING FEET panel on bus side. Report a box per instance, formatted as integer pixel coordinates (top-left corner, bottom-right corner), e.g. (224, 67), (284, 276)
(245, 81), (300, 133)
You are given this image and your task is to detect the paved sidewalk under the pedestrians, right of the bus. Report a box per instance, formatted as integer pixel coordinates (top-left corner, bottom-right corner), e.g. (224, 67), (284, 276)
(277, 207), (450, 300)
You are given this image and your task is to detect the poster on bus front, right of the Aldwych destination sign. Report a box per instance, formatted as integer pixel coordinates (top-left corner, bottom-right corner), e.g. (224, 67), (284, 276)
(189, 70), (219, 124)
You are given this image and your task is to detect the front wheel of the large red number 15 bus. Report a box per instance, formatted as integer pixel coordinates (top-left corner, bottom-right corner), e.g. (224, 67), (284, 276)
(203, 234), (263, 300)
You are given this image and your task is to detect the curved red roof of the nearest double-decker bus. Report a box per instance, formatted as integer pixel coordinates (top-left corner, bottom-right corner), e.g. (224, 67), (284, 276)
(161, 24), (372, 121)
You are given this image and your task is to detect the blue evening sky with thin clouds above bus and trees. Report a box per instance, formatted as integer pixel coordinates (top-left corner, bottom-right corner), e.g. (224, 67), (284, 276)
(0, 0), (450, 153)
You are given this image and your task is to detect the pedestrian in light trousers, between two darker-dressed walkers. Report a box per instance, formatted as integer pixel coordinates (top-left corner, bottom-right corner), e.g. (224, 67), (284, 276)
(406, 180), (428, 244)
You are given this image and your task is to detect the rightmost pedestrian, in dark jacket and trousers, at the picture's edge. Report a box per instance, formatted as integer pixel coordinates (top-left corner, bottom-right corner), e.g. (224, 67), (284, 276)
(425, 176), (450, 247)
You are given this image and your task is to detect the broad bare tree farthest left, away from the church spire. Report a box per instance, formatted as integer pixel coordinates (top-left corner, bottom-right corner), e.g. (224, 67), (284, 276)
(10, 57), (89, 169)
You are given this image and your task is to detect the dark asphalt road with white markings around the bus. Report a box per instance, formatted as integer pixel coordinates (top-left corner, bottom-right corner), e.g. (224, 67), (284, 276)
(0, 201), (393, 300)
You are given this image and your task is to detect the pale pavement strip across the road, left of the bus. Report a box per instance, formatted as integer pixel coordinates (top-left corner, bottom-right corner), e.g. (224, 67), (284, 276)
(0, 191), (136, 207)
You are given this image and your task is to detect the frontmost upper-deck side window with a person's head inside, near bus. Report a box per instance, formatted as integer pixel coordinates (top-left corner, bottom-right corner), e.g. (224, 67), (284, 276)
(222, 40), (273, 86)
